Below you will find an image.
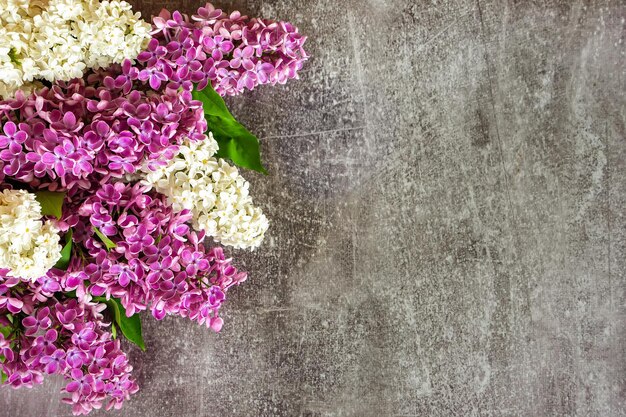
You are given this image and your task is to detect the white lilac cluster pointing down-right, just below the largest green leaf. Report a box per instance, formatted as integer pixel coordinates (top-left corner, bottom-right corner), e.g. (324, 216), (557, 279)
(143, 134), (269, 248)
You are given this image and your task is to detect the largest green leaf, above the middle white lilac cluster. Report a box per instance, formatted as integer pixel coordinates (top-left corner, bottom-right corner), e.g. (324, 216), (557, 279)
(192, 84), (267, 174)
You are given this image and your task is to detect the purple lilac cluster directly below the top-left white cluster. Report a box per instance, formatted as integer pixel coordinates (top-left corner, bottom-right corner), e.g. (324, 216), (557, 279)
(0, 72), (206, 192)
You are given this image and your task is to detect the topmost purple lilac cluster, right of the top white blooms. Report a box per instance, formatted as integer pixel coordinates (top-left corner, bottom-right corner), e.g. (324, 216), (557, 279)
(132, 3), (308, 95)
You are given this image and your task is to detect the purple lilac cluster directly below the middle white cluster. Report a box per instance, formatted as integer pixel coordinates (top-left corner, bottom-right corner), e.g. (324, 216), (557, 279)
(65, 183), (246, 331)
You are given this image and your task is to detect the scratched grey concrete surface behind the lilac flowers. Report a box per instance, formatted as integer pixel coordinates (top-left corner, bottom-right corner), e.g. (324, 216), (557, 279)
(0, 0), (626, 417)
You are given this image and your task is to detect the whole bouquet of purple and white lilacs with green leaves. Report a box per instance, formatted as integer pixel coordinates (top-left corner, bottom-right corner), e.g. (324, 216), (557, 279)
(0, 0), (308, 415)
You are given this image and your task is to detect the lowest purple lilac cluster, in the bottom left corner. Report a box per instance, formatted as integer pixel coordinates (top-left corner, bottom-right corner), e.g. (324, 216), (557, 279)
(0, 270), (138, 415)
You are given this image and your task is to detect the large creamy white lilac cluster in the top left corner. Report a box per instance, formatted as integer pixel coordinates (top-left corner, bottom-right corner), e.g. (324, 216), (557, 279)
(0, 0), (151, 98)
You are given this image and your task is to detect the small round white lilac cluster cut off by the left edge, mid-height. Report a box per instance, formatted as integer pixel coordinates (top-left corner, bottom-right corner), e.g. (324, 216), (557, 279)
(0, 190), (61, 279)
